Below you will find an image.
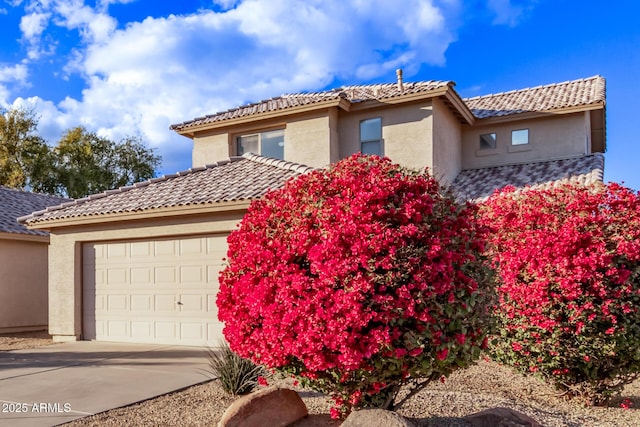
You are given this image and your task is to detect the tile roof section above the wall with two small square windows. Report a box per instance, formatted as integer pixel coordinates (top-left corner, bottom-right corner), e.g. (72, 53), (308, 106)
(464, 76), (606, 119)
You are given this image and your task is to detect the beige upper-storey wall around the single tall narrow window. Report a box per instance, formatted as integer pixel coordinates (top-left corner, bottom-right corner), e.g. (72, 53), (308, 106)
(338, 101), (433, 170)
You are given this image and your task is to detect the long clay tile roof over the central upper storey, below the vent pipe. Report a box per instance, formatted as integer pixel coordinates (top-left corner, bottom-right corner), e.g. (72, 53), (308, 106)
(171, 80), (454, 131)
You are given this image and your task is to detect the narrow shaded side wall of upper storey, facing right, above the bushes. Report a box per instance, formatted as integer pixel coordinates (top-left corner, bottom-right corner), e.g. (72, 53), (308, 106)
(431, 99), (462, 185)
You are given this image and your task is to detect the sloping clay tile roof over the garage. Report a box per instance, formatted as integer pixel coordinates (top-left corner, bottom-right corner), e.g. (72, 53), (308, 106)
(20, 153), (313, 224)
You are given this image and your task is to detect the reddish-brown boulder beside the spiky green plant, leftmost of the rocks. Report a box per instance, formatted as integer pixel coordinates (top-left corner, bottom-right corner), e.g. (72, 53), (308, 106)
(218, 387), (308, 427)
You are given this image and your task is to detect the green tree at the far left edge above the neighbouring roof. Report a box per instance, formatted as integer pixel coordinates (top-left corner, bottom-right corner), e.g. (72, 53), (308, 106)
(0, 108), (56, 193)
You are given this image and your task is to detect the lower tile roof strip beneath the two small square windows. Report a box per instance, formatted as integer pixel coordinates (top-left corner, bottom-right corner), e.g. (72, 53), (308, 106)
(450, 153), (604, 201)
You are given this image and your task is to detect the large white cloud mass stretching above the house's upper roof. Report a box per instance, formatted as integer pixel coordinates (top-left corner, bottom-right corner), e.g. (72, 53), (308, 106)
(5, 0), (459, 176)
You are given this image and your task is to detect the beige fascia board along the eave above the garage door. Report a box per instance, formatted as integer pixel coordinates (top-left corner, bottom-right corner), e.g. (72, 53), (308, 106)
(26, 200), (251, 230)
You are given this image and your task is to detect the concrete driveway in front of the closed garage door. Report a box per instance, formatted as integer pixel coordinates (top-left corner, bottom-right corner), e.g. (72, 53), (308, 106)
(0, 341), (210, 427)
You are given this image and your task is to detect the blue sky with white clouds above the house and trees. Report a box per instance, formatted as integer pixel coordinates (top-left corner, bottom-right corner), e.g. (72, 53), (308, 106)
(0, 0), (640, 190)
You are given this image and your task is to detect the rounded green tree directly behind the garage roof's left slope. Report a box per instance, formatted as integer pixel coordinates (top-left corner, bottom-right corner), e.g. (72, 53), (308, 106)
(54, 127), (160, 198)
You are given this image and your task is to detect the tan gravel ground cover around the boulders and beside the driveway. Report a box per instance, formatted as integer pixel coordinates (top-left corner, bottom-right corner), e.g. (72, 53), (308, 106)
(0, 335), (640, 427)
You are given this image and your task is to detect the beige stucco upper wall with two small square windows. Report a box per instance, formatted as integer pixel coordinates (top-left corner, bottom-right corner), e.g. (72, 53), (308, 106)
(462, 112), (589, 169)
